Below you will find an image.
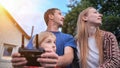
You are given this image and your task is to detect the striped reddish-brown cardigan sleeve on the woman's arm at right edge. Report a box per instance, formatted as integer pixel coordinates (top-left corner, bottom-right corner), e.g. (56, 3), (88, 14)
(99, 32), (120, 68)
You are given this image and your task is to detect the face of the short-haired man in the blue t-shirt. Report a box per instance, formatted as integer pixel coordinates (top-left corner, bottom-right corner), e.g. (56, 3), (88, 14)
(53, 10), (64, 26)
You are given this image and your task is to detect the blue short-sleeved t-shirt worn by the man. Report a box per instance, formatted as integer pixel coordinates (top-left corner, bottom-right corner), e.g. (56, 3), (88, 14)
(27, 32), (76, 68)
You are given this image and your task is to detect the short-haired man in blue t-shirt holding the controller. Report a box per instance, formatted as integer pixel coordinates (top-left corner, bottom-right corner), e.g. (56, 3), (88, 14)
(12, 8), (76, 68)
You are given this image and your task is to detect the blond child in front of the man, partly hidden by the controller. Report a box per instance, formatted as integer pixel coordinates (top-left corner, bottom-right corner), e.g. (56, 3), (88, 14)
(28, 31), (62, 68)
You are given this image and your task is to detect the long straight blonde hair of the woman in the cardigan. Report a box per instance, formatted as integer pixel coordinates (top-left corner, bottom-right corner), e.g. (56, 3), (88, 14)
(75, 7), (103, 68)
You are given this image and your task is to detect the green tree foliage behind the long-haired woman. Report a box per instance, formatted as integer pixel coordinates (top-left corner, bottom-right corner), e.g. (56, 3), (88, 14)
(62, 0), (120, 35)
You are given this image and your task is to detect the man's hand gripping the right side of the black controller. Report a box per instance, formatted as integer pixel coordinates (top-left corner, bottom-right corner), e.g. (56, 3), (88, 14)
(37, 49), (58, 68)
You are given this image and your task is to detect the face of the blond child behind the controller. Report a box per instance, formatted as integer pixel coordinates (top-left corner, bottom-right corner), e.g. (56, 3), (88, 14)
(40, 36), (56, 52)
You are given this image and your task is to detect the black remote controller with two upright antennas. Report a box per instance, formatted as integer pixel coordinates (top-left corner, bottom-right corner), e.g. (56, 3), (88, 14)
(19, 36), (45, 66)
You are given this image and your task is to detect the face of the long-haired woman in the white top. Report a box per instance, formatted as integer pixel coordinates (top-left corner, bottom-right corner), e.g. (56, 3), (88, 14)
(86, 8), (102, 26)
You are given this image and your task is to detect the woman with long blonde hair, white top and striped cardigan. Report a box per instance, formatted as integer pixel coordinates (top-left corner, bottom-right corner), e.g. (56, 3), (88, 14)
(76, 7), (120, 68)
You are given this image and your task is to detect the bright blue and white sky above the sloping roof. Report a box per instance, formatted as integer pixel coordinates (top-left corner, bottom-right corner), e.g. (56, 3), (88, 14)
(0, 0), (70, 36)
